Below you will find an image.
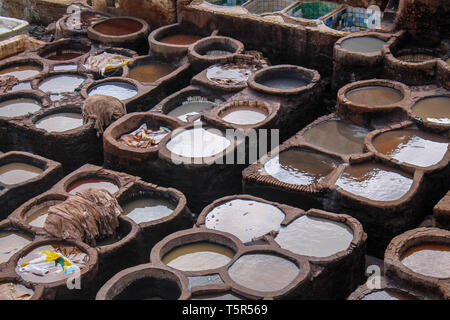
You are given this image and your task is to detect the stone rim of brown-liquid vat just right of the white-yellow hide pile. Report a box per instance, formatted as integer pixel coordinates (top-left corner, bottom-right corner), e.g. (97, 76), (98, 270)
(122, 55), (190, 86)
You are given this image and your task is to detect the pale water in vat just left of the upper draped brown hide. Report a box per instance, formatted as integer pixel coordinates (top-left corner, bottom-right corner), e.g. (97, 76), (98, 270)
(35, 112), (83, 132)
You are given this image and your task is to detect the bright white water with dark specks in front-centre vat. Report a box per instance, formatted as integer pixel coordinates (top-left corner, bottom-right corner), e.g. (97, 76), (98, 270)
(205, 199), (285, 243)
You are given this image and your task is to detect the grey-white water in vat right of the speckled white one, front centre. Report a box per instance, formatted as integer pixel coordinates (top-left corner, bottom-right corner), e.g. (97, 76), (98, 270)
(275, 216), (353, 258)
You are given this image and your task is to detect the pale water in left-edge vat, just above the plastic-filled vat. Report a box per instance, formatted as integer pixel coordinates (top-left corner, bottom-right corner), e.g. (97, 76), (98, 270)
(0, 219), (35, 268)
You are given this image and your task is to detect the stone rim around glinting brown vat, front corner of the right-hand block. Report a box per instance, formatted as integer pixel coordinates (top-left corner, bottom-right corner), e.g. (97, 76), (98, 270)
(330, 158), (424, 208)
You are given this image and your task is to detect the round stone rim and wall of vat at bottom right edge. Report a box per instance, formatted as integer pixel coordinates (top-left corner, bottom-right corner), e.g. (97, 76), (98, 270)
(384, 228), (450, 299)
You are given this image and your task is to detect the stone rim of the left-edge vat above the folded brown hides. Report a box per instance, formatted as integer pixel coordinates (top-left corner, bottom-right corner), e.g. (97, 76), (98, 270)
(0, 151), (62, 218)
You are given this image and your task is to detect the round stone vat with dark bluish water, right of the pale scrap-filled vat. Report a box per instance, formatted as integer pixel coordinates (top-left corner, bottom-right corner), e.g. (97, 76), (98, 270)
(248, 65), (320, 95)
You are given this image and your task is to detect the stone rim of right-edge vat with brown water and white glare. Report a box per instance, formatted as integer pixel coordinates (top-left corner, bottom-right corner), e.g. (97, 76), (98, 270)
(364, 120), (450, 173)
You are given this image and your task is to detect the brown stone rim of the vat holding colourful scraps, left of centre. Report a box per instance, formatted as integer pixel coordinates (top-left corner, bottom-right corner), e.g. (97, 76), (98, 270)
(103, 112), (185, 161)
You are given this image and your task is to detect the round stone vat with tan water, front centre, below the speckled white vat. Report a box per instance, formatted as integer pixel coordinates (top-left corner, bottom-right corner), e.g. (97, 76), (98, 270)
(150, 229), (242, 276)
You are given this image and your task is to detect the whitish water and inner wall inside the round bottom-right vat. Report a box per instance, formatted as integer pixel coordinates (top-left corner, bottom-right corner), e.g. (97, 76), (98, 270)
(401, 244), (450, 278)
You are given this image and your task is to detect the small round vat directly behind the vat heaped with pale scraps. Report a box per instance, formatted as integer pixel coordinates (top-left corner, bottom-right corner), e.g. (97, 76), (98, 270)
(188, 36), (244, 71)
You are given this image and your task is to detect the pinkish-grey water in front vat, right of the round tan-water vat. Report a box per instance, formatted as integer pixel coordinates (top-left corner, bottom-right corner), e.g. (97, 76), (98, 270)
(228, 253), (300, 292)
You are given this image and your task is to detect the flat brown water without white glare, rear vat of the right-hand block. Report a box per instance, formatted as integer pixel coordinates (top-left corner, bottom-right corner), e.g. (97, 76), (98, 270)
(304, 120), (369, 154)
